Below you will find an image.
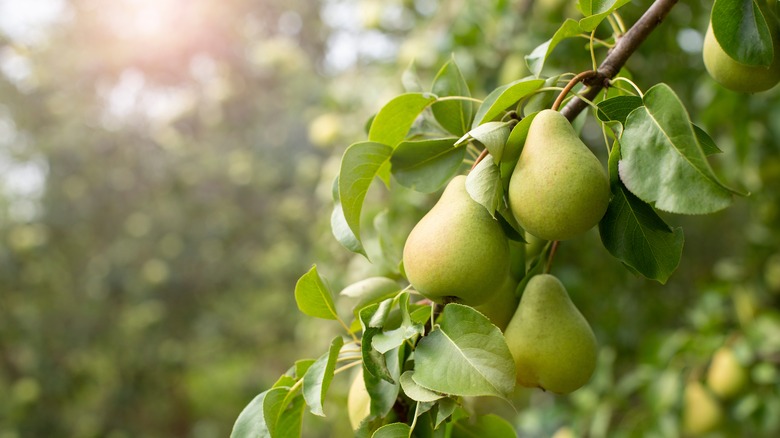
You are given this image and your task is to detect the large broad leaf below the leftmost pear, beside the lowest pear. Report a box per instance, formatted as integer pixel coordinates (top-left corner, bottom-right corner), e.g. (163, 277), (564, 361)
(412, 304), (515, 397)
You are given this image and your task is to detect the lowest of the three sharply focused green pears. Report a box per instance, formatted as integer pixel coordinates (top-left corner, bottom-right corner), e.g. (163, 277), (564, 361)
(504, 274), (598, 394)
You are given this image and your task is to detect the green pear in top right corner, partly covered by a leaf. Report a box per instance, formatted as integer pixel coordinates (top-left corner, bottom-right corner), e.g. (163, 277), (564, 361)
(702, 22), (780, 93)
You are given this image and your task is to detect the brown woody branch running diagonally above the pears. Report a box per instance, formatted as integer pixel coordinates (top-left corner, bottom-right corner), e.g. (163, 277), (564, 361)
(561, 0), (678, 120)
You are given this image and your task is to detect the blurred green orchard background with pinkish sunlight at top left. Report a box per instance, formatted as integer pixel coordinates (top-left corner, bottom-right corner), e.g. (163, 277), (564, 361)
(0, 0), (780, 438)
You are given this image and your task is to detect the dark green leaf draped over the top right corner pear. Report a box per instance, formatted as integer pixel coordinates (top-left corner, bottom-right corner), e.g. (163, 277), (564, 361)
(710, 0), (775, 66)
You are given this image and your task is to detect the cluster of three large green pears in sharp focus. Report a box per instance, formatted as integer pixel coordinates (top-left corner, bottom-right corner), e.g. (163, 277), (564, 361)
(403, 110), (610, 394)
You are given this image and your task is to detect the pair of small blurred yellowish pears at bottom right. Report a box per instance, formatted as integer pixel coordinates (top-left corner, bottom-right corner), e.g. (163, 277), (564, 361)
(682, 346), (750, 436)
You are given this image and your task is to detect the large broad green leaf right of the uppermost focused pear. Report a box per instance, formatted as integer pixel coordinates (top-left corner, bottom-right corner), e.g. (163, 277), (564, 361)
(619, 84), (732, 214)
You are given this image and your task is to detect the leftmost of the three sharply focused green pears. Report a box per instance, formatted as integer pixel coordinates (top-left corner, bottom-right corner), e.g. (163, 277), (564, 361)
(403, 175), (509, 306)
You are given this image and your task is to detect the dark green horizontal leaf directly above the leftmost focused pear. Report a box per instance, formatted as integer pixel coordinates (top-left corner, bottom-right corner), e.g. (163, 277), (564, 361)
(390, 138), (466, 193)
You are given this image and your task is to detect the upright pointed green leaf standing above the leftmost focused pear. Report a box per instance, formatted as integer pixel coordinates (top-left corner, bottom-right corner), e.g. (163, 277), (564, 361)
(431, 60), (474, 136)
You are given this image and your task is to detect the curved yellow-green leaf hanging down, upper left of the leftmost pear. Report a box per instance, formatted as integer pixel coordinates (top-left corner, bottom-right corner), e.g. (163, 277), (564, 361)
(338, 142), (393, 248)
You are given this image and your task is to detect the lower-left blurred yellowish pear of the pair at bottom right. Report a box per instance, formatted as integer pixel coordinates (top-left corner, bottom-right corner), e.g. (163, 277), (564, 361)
(682, 380), (723, 436)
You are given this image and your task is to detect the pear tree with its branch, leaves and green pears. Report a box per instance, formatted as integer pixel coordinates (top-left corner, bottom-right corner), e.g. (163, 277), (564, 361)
(232, 0), (780, 438)
